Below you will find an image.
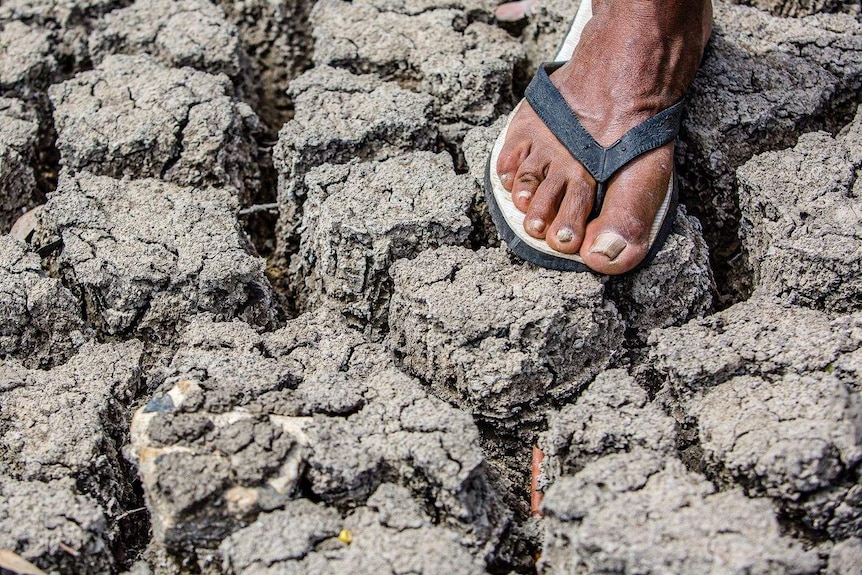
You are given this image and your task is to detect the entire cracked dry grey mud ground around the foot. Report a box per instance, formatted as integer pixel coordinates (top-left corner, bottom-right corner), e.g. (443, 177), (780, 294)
(0, 0), (862, 575)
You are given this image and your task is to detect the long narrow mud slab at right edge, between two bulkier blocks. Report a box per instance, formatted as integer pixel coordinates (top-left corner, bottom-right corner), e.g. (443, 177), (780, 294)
(649, 297), (862, 404)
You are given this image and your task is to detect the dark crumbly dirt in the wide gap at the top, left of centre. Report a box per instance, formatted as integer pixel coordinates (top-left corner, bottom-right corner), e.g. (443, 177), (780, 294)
(215, 0), (313, 129)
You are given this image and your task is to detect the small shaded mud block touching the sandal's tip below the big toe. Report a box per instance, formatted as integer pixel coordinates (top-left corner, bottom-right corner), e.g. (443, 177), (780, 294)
(608, 206), (715, 341)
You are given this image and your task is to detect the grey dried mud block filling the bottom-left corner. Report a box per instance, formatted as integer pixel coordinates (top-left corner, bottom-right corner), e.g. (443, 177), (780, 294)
(0, 476), (116, 574)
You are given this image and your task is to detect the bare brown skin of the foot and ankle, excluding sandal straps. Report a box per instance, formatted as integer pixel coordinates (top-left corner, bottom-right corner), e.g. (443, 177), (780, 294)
(497, 0), (712, 275)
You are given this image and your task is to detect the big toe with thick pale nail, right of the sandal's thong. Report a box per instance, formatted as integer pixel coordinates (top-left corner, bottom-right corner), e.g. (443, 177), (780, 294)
(580, 145), (673, 275)
